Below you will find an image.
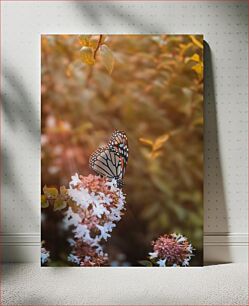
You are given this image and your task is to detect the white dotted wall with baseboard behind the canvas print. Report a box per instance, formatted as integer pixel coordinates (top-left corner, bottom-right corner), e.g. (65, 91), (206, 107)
(1, 1), (248, 262)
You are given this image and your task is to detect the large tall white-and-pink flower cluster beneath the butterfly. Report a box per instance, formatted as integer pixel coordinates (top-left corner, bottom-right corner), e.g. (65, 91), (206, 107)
(63, 174), (125, 266)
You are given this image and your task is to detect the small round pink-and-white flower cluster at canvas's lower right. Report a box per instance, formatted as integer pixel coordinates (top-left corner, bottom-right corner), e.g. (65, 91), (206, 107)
(149, 233), (193, 267)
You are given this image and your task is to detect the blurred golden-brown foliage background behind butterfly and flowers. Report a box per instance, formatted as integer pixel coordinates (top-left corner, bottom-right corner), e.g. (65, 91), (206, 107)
(41, 35), (203, 265)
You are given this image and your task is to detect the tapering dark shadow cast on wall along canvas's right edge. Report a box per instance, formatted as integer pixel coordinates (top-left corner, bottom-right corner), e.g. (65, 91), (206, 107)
(204, 41), (231, 263)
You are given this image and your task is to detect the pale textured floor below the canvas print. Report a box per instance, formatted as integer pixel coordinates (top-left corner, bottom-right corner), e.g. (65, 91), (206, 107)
(1, 263), (248, 305)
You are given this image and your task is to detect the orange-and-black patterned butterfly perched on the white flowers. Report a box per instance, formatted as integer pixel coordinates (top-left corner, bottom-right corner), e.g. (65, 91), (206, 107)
(89, 130), (129, 188)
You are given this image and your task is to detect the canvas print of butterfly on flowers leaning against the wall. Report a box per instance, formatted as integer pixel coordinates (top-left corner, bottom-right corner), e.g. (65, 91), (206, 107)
(41, 34), (203, 268)
